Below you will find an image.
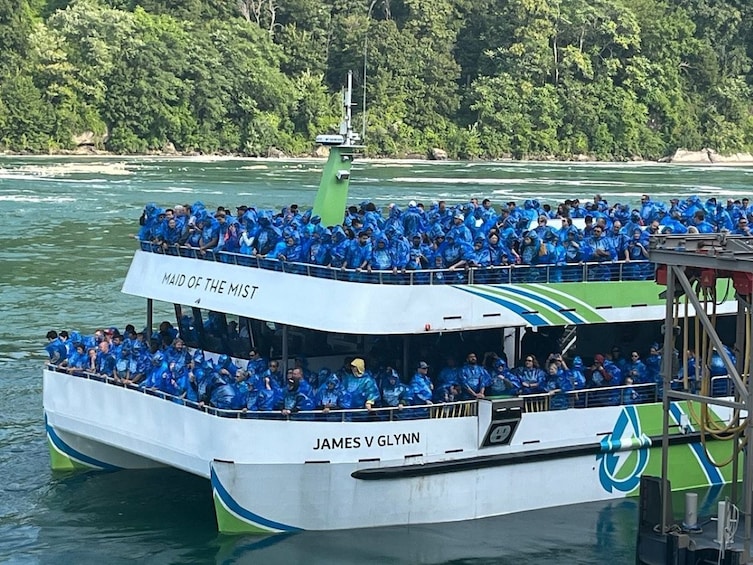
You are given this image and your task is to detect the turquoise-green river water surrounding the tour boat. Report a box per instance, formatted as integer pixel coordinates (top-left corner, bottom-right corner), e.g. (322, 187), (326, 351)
(0, 157), (753, 565)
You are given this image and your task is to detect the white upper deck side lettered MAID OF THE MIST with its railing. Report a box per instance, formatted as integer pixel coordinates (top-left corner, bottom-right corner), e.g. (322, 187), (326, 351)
(123, 242), (734, 335)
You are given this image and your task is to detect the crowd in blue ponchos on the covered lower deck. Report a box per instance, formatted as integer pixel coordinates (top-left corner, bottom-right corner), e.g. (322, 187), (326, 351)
(45, 322), (734, 417)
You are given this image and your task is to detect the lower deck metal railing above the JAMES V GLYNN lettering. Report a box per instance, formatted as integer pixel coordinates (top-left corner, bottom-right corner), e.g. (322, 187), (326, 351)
(47, 364), (734, 422)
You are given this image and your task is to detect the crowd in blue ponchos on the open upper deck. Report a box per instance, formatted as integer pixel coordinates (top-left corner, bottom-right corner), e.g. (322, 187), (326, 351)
(138, 195), (753, 282)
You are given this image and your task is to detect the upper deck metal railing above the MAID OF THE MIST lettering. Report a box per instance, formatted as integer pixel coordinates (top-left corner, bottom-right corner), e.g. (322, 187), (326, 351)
(140, 241), (654, 285)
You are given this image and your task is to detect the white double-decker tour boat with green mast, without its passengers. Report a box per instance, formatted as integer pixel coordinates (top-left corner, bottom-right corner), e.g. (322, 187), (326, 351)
(44, 77), (734, 533)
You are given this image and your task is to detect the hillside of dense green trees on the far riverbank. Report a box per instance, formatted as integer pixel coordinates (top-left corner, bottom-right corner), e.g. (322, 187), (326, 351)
(0, 0), (753, 159)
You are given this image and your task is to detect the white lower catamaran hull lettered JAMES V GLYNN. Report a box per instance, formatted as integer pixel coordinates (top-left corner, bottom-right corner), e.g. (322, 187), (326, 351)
(44, 371), (731, 533)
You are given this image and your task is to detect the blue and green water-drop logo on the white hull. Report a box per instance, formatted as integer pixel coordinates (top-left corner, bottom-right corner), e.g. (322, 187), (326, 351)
(596, 406), (651, 493)
